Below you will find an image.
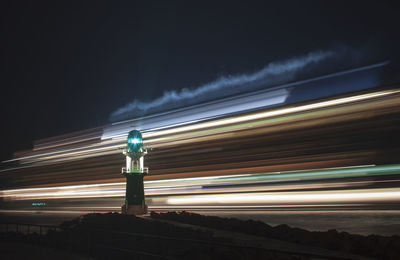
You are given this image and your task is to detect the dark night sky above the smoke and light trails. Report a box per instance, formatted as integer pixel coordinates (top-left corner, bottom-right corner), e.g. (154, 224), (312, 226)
(0, 1), (400, 159)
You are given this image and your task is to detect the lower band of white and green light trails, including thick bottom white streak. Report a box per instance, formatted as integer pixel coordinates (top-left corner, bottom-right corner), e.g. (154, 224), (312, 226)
(0, 165), (400, 207)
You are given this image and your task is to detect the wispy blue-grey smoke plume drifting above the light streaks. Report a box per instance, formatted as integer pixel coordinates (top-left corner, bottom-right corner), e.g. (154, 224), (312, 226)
(111, 51), (335, 121)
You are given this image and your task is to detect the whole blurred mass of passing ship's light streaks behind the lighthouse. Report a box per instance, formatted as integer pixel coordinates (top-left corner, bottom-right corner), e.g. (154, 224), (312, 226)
(0, 70), (400, 214)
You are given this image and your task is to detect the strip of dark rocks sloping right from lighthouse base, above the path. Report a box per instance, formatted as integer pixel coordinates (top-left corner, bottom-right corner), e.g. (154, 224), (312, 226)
(151, 211), (400, 259)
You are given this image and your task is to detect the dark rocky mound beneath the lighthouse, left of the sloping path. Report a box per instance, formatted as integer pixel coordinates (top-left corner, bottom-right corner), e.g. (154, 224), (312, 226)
(1, 213), (301, 260)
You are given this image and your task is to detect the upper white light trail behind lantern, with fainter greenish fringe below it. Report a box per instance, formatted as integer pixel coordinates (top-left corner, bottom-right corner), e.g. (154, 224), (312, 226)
(1, 90), (400, 171)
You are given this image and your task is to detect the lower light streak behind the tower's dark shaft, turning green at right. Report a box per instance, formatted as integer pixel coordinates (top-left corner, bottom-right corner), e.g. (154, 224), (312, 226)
(0, 165), (400, 201)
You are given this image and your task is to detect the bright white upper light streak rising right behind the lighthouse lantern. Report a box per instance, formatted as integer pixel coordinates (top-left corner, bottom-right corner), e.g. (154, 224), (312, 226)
(0, 90), (400, 168)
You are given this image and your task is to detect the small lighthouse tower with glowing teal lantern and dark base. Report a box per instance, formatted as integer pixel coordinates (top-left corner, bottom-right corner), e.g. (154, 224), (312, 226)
(122, 130), (149, 215)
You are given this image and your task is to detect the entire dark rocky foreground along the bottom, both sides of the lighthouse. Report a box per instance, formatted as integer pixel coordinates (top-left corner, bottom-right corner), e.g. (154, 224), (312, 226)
(2, 212), (400, 259)
